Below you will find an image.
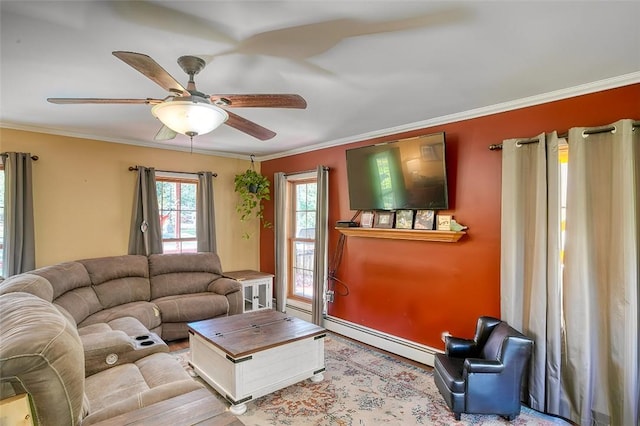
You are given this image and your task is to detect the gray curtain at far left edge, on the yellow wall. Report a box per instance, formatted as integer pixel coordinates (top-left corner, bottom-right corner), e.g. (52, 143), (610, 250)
(2, 152), (36, 277)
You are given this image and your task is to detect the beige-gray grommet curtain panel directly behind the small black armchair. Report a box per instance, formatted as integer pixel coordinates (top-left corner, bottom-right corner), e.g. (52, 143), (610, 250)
(500, 132), (562, 414)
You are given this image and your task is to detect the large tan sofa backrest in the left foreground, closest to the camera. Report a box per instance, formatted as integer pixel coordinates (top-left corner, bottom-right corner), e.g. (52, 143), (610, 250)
(0, 293), (84, 425)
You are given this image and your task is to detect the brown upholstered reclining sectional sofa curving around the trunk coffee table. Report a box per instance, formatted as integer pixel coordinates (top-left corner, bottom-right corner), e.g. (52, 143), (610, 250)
(0, 253), (242, 425)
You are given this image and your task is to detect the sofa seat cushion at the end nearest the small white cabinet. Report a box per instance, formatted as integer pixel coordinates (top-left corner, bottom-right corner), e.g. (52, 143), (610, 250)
(153, 292), (229, 323)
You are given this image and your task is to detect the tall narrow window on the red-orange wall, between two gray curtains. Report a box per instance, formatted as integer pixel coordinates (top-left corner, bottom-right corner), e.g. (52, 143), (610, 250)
(287, 178), (317, 302)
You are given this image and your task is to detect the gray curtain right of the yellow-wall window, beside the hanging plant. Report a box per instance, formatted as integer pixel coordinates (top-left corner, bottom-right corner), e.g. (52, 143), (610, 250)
(196, 172), (216, 253)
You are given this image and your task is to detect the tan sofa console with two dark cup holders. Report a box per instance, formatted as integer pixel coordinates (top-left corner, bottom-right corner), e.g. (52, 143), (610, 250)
(80, 330), (169, 377)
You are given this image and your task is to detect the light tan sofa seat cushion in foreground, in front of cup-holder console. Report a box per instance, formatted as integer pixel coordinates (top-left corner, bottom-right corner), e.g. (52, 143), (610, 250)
(82, 353), (203, 426)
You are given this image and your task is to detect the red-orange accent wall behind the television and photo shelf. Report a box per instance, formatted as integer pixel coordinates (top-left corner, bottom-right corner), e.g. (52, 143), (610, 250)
(260, 84), (640, 348)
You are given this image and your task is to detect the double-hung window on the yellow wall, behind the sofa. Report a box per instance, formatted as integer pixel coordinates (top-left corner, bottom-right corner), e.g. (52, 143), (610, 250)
(156, 176), (198, 253)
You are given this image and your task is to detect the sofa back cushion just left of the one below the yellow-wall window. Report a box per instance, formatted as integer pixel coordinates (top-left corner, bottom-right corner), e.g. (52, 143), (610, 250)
(78, 255), (151, 308)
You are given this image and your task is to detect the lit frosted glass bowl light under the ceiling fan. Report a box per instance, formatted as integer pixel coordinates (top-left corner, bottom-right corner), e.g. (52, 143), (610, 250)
(151, 100), (229, 137)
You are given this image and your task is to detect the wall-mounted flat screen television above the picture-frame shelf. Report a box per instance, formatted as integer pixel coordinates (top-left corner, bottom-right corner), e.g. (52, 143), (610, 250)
(347, 132), (449, 210)
